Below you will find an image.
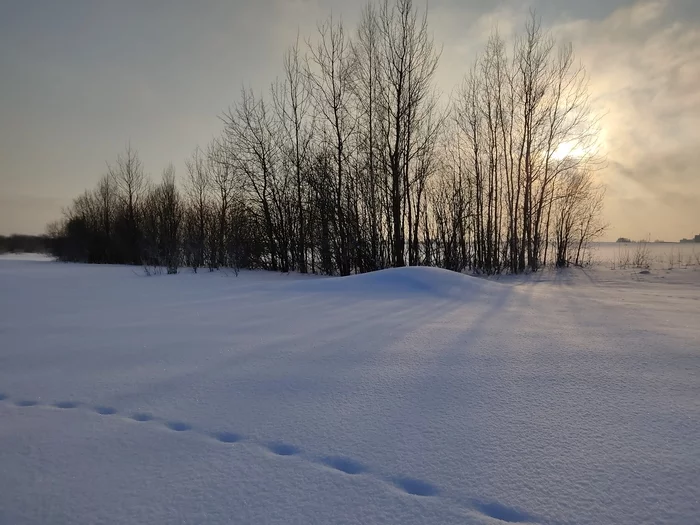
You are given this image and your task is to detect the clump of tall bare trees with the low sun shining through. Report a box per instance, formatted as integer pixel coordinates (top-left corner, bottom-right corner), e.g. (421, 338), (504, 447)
(449, 17), (604, 273)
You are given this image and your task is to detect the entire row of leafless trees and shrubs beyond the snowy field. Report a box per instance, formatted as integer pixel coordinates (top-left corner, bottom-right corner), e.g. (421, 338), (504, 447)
(43, 0), (604, 275)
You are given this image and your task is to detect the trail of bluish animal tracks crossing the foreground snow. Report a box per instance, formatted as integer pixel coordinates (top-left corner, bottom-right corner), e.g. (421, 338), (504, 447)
(0, 386), (535, 523)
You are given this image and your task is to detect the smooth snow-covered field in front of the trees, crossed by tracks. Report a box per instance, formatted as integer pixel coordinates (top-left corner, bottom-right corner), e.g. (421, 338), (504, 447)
(0, 258), (700, 525)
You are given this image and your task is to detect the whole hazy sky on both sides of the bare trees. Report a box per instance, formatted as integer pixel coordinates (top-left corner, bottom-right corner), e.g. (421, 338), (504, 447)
(0, 0), (700, 240)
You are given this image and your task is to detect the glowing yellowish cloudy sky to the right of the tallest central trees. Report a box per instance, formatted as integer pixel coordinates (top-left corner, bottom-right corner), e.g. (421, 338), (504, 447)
(438, 0), (700, 240)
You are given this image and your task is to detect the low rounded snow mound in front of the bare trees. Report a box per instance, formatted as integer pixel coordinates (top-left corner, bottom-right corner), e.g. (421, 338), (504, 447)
(292, 266), (504, 299)
